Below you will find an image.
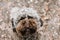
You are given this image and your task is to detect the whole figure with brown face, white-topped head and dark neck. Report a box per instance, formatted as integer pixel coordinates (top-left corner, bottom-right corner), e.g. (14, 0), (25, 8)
(10, 7), (43, 40)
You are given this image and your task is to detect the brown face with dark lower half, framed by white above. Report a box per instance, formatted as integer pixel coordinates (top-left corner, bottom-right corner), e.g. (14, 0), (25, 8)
(16, 17), (37, 35)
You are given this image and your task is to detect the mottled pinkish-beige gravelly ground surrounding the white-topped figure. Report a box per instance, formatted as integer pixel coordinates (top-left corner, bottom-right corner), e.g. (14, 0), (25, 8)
(0, 0), (60, 40)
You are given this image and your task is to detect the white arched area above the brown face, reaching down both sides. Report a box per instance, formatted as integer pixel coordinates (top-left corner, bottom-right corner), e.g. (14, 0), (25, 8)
(10, 7), (40, 26)
